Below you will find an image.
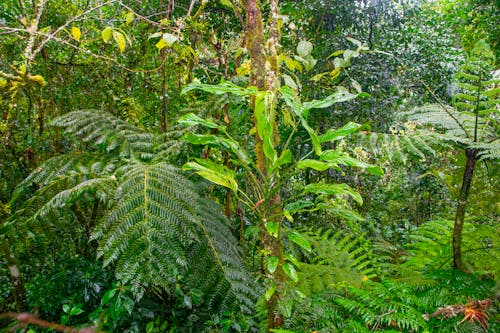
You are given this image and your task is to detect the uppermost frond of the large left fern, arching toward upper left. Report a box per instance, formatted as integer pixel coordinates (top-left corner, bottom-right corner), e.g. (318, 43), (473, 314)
(53, 110), (155, 159)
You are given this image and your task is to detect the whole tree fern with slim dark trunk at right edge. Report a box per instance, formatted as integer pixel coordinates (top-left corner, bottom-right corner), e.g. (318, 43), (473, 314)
(407, 41), (500, 270)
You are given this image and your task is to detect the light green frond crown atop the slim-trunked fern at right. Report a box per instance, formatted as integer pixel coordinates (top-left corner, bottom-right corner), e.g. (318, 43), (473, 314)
(403, 41), (500, 159)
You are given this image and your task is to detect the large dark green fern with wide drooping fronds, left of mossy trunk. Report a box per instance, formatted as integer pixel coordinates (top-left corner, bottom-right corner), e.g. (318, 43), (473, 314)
(6, 111), (257, 312)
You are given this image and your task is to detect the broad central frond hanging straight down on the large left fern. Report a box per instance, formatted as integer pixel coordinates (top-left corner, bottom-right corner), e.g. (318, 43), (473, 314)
(92, 163), (199, 288)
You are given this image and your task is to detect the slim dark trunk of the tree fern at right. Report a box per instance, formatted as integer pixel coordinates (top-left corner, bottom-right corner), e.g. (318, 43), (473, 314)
(453, 148), (477, 272)
